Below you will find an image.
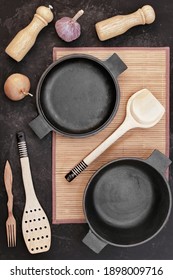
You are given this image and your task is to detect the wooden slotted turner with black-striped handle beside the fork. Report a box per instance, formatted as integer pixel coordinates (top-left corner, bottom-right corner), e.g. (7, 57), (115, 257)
(17, 132), (51, 254)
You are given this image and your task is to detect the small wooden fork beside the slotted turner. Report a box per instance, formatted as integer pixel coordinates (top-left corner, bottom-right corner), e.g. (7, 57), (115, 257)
(4, 160), (16, 247)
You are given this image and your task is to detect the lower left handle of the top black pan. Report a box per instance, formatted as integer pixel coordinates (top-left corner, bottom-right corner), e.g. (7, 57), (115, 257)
(29, 115), (52, 139)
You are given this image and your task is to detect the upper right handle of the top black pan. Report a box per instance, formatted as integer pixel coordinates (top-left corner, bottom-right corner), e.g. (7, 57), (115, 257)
(103, 53), (127, 78)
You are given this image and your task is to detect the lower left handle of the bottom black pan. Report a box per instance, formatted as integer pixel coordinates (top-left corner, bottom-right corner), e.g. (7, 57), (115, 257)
(82, 230), (107, 254)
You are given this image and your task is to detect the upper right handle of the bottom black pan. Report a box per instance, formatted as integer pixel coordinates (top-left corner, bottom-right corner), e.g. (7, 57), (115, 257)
(145, 150), (172, 174)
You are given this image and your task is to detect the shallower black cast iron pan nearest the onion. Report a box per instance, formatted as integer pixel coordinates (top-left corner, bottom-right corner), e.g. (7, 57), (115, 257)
(30, 54), (127, 138)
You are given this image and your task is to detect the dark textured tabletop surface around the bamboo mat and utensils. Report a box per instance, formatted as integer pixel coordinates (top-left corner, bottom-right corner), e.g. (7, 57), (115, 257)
(0, 0), (173, 260)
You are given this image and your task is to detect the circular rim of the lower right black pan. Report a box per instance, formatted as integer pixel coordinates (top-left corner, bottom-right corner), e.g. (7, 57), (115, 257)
(83, 157), (172, 248)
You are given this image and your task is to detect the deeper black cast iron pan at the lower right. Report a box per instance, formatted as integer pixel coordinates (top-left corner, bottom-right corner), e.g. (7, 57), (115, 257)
(83, 150), (172, 253)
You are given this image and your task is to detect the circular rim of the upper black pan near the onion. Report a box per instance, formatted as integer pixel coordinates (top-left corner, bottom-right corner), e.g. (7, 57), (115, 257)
(36, 54), (120, 138)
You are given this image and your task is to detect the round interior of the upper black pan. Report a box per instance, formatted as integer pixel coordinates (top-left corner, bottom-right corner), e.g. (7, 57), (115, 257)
(40, 58), (117, 134)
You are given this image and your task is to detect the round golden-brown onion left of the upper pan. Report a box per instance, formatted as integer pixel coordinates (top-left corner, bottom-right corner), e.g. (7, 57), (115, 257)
(4, 73), (31, 101)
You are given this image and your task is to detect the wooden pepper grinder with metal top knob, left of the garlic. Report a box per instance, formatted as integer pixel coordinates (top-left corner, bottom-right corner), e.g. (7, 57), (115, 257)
(5, 5), (53, 62)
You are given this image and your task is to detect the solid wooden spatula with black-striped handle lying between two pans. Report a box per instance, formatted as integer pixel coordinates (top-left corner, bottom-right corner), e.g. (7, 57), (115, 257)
(65, 89), (165, 182)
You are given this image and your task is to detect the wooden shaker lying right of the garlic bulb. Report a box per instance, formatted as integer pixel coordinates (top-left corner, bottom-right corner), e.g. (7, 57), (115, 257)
(95, 5), (155, 41)
